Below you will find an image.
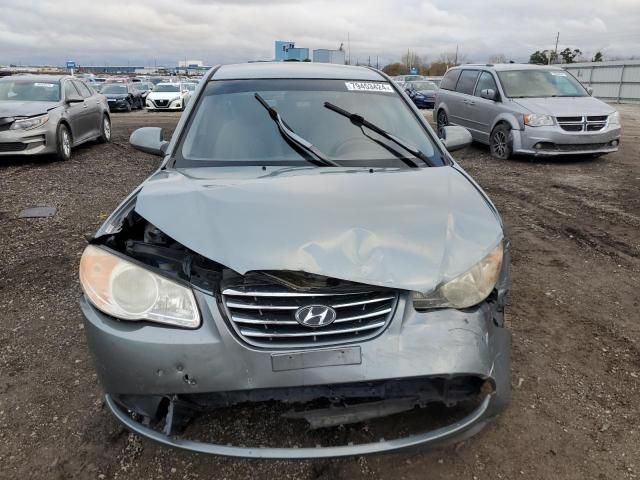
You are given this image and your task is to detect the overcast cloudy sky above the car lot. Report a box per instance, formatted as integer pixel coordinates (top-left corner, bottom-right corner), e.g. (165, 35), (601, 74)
(0, 0), (640, 66)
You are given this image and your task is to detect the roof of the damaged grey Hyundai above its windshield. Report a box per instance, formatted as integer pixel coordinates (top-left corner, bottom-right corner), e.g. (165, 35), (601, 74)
(211, 62), (386, 81)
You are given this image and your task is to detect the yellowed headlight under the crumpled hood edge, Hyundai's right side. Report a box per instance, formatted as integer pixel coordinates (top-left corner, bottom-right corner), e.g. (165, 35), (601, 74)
(413, 242), (503, 310)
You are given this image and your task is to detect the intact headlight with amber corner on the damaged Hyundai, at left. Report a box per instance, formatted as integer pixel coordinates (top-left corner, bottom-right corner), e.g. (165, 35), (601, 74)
(80, 245), (200, 328)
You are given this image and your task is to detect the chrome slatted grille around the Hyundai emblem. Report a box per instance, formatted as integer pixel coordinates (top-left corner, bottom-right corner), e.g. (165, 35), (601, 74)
(222, 286), (398, 348)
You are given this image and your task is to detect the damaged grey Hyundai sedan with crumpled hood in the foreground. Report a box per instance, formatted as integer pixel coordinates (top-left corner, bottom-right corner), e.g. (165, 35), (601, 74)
(80, 63), (511, 458)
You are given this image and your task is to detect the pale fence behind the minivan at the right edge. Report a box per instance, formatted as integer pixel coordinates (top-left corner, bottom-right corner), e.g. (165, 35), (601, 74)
(561, 60), (640, 103)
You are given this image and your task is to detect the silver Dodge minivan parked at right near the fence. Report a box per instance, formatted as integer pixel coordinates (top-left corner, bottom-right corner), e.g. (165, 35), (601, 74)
(434, 64), (621, 159)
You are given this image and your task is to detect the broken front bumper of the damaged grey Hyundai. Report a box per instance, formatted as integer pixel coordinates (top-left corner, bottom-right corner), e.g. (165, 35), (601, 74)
(80, 284), (511, 458)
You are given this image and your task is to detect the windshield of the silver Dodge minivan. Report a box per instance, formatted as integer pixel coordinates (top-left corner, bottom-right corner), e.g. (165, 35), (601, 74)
(498, 70), (589, 98)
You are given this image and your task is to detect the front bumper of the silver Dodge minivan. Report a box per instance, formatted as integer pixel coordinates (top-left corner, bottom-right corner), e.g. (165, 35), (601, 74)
(512, 125), (621, 156)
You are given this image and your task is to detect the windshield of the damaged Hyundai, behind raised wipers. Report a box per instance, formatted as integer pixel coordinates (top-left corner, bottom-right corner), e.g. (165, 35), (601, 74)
(176, 79), (444, 167)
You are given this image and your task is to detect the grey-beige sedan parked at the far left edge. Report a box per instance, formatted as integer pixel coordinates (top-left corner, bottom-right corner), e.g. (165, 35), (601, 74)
(0, 75), (111, 160)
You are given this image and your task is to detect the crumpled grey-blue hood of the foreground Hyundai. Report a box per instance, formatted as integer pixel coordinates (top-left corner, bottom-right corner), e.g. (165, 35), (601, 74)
(135, 167), (503, 292)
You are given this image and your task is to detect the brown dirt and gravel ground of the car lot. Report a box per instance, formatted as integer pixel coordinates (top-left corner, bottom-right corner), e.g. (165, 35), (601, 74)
(0, 106), (640, 480)
